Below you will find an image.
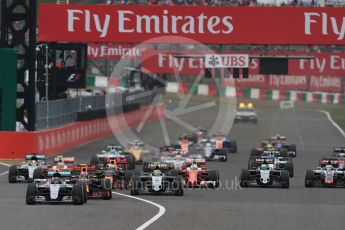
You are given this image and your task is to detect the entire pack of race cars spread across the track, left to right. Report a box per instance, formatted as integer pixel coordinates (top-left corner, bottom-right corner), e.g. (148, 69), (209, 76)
(8, 129), (345, 205)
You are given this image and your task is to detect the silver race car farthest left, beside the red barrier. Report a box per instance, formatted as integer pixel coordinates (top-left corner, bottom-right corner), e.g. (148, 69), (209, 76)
(8, 154), (46, 183)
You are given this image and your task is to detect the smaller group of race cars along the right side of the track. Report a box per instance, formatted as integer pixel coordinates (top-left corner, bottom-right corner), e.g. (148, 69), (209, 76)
(240, 135), (345, 188)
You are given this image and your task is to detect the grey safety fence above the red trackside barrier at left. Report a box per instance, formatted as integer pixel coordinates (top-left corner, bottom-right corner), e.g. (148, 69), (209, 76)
(36, 89), (164, 130)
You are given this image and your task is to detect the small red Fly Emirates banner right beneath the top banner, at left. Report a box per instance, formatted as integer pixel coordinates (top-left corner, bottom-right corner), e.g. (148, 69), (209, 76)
(87, 44), (147, 60)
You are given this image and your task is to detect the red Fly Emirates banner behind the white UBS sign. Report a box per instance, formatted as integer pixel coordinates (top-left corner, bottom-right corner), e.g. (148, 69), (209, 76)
(142, 50), (345, 76)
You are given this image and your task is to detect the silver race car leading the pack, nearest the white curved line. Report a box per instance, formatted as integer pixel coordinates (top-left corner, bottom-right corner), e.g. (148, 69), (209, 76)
(26, 171), (86, 205)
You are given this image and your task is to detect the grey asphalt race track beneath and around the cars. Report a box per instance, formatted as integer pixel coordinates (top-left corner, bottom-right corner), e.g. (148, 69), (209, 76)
(0, 102), (345, 230)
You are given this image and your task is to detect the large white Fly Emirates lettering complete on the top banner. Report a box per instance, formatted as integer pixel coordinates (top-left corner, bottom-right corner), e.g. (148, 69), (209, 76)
(67, 9), (234, 37)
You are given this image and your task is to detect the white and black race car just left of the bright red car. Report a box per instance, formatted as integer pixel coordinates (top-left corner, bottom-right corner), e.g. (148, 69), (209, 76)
(130, 170), (183, 196)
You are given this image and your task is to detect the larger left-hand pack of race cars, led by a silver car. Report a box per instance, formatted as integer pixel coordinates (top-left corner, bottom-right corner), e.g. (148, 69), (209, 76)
(8, 129), (237, 205)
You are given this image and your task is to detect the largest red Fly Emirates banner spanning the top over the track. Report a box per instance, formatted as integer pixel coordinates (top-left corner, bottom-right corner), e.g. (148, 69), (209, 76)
(38, 4), (345, 45)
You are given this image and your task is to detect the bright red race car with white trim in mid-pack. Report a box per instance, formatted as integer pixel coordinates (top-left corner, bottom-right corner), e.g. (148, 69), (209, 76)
(177, 163), (219, 188)
